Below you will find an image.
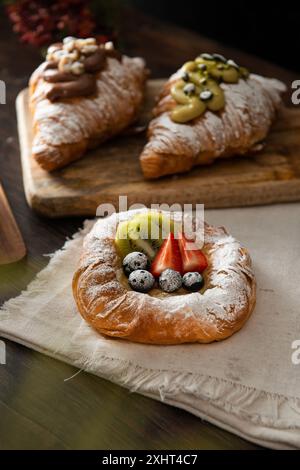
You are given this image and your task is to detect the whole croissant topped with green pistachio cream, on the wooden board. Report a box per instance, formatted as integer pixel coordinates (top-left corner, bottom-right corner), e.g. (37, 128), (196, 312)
(140, 54), (286, 178)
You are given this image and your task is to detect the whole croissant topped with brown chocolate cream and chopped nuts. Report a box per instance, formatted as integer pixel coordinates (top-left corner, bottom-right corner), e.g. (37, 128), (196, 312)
(30, 37), (147, 171)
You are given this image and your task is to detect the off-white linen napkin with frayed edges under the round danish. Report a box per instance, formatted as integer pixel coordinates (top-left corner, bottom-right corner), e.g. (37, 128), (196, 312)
(0, 204), (300, 449)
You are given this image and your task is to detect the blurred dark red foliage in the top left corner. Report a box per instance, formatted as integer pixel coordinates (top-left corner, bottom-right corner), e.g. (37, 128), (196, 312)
(0, 0), (122, 47)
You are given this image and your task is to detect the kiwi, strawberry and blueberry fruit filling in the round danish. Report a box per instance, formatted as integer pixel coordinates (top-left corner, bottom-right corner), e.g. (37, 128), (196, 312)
(115, 211), (208, 294)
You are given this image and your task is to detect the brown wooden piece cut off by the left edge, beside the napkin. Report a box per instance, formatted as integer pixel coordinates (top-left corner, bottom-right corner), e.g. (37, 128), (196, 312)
(0, 183), (26, 264)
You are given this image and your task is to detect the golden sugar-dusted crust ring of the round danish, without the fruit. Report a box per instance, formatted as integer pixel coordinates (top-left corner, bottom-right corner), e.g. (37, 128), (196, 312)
(73, 211), (256, 344)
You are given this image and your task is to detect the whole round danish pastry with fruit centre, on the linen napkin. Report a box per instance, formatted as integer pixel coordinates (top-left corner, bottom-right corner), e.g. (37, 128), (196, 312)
(73, 210), (256, 344)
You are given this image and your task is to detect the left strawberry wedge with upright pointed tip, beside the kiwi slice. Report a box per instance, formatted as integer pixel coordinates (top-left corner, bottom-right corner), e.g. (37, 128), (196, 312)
(150, 232), (182, 277)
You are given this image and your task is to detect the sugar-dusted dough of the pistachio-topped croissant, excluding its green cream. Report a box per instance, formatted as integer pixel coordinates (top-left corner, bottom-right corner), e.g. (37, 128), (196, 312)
(140, 71), (286, 179)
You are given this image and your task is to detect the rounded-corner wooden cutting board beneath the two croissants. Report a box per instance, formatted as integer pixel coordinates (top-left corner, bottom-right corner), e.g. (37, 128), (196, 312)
(17, 80), (300, 217)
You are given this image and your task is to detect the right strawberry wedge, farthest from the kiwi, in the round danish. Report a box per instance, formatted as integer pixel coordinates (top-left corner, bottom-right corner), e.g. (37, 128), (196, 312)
(178, 233), (208, 274)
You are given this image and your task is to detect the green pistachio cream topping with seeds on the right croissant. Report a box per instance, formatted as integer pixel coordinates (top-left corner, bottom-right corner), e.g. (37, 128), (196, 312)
(171, 53), (249, 123)
